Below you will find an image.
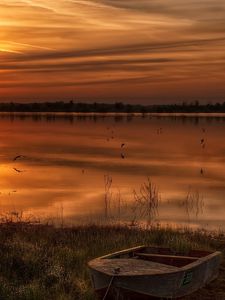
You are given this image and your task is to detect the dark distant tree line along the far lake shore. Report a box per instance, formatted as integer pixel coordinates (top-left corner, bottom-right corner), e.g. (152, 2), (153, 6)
(0, 101), (225, 113)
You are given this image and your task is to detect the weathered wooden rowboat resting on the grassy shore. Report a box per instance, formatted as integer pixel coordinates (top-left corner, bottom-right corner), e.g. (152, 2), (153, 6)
(88, 246), (221, 300)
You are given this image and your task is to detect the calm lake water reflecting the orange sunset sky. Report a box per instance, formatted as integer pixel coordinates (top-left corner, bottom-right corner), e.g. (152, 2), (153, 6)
(0, 114), (225, 230)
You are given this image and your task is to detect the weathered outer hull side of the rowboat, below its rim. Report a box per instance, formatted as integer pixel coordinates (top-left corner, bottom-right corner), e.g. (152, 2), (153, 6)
(90, 247), (220, 299)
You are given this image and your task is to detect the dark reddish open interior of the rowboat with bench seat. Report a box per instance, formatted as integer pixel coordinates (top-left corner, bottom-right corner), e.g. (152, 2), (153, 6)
(109, 247), (212, 267)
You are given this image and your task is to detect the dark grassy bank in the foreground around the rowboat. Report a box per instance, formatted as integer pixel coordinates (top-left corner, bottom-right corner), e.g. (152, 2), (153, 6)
(0, 223), (225, 300)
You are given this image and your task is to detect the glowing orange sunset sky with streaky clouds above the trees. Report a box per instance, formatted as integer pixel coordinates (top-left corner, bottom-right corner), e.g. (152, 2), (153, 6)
(0, 0), (225, 104)
